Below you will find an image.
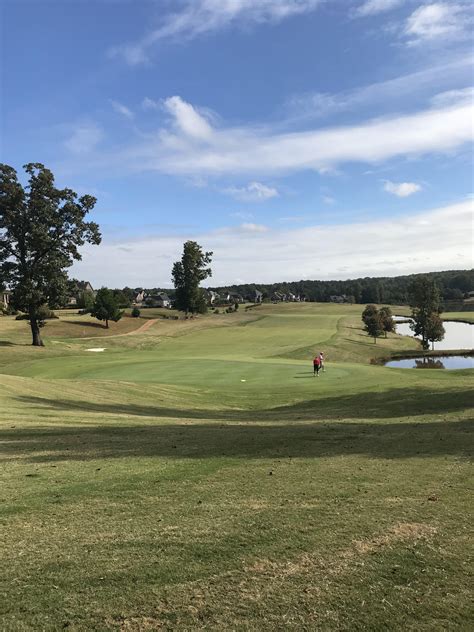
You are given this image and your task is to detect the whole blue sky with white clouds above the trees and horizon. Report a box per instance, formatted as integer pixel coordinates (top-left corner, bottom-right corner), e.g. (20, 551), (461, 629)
(0, 0), (474, 287)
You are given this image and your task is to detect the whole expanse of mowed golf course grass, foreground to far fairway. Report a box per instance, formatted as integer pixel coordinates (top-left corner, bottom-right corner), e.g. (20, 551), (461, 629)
(0, 304), (474, 631)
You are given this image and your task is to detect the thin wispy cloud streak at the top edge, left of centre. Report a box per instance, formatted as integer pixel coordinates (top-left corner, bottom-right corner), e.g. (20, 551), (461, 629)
(109, 0), (321, 66)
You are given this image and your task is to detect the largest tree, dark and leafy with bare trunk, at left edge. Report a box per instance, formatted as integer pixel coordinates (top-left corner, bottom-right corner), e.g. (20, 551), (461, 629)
(0, 163), (101, 346)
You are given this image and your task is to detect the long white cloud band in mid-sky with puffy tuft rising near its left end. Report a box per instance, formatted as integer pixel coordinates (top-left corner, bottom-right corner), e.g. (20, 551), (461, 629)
(118, 92), (473, 177)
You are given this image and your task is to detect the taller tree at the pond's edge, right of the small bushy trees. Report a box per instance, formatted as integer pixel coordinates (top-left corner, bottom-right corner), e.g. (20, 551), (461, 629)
(410, 276), (444, 349)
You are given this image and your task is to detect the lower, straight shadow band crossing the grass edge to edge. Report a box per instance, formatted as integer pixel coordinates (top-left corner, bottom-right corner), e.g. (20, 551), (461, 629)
(2, 421), (472, 463)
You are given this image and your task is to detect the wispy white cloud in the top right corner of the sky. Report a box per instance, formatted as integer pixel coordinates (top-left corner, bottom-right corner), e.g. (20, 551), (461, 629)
(404, 2), (472, 44)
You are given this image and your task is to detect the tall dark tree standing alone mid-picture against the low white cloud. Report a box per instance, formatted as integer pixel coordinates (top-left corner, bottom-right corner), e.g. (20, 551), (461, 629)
(172, 241), (212, 314)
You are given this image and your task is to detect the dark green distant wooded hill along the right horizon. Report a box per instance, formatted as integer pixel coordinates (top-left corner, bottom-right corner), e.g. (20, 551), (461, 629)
(209, 269), (474, 305)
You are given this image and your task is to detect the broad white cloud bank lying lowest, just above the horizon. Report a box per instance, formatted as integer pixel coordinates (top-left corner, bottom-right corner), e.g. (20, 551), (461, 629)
(72, 200), (474, 287)
